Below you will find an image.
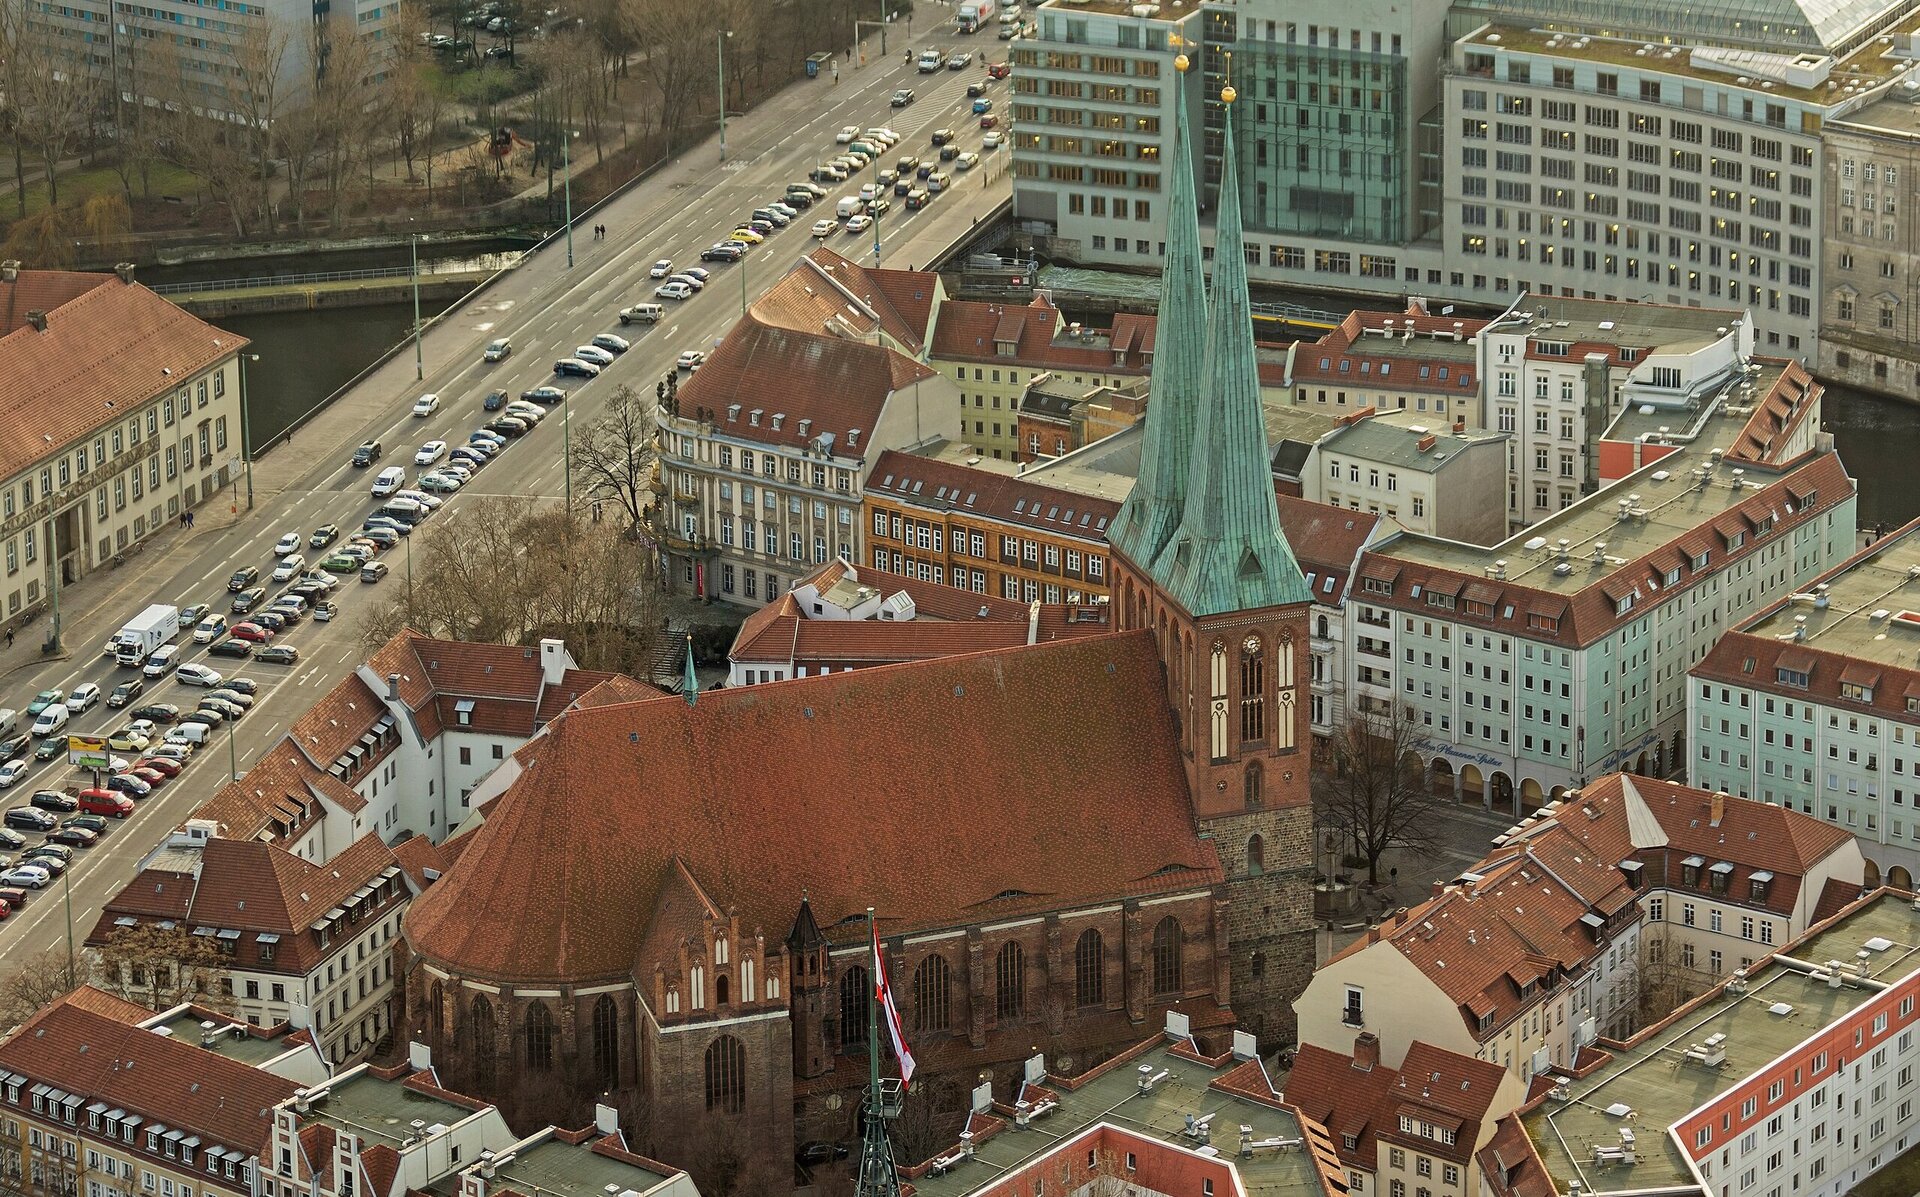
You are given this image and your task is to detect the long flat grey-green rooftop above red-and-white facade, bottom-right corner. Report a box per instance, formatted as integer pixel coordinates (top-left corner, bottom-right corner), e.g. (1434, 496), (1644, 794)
(1524, 895), (1920, 1193)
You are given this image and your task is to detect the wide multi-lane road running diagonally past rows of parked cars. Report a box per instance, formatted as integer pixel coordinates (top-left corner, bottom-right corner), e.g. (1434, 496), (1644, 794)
(0, 14), (1010, 968)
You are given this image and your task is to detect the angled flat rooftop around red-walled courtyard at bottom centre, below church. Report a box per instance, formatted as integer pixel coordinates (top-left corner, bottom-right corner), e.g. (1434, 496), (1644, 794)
(914, 1041), (1323, 1197)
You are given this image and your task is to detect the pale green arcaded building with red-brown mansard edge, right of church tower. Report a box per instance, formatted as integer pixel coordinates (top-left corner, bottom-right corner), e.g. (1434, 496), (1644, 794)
(1346, 359), (1855, 813)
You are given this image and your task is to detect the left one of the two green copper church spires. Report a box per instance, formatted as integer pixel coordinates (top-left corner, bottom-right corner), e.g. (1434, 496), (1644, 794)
(1106, 54), (1206, 569)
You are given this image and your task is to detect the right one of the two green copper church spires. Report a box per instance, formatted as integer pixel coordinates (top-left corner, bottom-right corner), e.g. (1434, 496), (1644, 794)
(1148, 85), (1313, 617)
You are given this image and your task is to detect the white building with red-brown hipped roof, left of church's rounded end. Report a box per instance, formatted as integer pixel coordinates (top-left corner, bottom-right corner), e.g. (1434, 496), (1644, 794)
(86, 818), (415, 1064)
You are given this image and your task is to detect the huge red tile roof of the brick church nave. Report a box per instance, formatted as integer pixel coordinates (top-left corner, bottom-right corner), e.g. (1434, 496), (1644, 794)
(407, 632), (1219, 980)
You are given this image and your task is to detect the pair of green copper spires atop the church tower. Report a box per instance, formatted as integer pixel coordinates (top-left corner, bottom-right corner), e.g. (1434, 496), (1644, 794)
(1108, 54), (1313, 617)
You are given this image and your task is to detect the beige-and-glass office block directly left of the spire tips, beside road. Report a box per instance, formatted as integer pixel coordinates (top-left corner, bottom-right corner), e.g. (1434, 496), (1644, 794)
(1006, 0), (1200, 270)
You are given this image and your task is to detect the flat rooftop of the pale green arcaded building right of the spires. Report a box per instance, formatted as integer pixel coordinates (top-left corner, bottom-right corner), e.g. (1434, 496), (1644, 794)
(1377, 363), (1780, 596)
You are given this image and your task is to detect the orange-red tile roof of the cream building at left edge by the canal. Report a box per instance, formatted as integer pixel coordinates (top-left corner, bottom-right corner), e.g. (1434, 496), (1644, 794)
(0, 271), (248, 488)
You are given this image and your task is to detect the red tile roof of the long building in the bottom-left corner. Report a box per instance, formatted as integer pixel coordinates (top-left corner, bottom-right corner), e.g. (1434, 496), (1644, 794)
(0, 997), (298, 1155)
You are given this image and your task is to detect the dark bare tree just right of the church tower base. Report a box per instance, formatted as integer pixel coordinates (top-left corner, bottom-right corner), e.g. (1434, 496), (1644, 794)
(1313, 705), (1446, 886)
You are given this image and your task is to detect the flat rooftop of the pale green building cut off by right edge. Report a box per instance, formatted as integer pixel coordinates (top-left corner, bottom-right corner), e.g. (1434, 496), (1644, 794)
(1740, 525), (1920, 669)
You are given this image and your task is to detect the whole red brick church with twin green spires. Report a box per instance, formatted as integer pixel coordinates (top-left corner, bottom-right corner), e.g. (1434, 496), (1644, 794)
(405, 61), (1313, 1191)
